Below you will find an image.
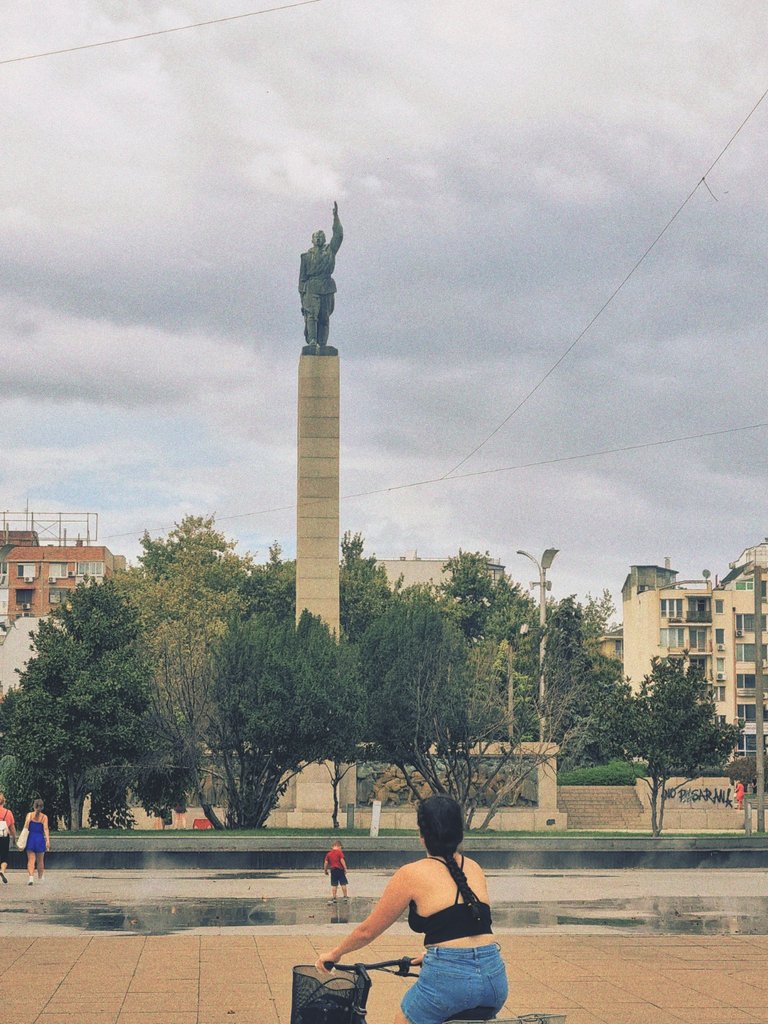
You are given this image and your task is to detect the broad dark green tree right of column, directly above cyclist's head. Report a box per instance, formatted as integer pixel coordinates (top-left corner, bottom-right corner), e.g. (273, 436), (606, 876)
(361, 590), (548, 828)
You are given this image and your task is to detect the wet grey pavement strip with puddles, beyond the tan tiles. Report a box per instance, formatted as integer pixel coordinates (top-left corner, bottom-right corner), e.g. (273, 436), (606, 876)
(0, 869), (768, 936)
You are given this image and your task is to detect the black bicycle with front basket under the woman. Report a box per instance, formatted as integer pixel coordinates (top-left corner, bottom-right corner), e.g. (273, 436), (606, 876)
(291, 956), (565, 1024)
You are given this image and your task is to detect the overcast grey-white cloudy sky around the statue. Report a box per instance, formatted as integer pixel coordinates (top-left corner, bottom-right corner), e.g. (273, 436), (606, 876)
(0, 0), (768, 617)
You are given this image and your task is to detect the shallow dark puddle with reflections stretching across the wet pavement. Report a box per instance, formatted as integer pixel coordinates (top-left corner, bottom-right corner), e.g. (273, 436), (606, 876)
(0, 897), (768, 935)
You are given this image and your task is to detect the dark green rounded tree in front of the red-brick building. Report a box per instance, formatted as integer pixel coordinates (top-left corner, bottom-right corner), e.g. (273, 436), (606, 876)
(9, 580), (148, 829)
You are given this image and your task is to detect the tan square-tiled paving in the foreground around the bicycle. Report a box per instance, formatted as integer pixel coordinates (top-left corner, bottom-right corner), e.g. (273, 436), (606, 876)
(0, 931), (768, 1024)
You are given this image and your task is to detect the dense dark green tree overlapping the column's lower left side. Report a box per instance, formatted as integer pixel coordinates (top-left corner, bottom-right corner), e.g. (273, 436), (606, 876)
(210, 611), (336, 828)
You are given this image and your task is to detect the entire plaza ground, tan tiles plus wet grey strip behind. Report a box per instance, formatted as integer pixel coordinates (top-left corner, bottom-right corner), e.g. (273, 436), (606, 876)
(0, 870), (768, 1024)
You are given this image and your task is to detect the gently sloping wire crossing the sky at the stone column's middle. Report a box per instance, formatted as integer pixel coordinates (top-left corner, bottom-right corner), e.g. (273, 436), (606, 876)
(104, 420), (768, 541)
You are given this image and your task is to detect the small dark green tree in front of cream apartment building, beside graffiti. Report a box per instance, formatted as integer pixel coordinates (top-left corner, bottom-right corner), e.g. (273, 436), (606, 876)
(623, 658), (739, 836)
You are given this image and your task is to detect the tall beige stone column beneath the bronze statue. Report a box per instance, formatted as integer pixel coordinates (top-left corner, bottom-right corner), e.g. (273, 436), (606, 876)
(296, 349), (339, 634)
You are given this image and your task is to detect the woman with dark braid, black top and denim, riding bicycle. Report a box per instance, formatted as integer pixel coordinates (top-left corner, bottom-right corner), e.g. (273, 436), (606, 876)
(315, 796), (508, 1024)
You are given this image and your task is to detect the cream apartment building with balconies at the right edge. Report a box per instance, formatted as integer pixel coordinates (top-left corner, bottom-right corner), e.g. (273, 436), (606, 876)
(622, 540), (768, 753)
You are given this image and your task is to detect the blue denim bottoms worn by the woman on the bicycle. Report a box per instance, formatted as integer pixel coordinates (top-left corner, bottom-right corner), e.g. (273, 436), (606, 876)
(400, 942), (509, 1024)
